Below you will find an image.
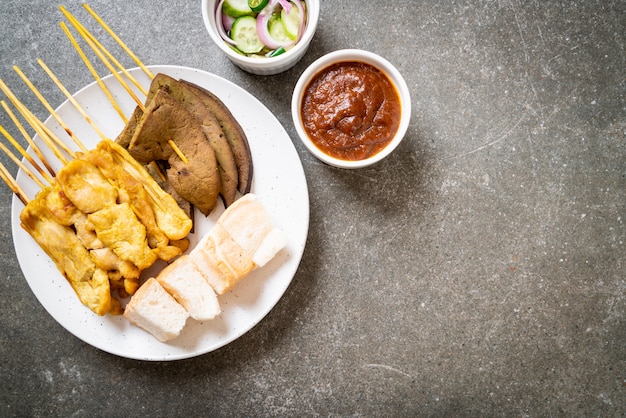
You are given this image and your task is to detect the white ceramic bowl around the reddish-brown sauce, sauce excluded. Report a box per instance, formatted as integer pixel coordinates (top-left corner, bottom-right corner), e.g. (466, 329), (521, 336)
(291, 49), (411, 168)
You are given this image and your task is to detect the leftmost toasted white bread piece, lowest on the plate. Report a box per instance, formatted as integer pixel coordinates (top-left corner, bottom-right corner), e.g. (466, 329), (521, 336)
(124, 277), (189, 342)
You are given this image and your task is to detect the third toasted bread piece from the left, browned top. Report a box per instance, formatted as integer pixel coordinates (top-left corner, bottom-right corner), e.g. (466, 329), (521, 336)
(189, 224), (256, 295)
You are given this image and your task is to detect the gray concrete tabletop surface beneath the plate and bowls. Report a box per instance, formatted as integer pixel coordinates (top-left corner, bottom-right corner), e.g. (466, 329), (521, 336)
(0, 0), (626, 417)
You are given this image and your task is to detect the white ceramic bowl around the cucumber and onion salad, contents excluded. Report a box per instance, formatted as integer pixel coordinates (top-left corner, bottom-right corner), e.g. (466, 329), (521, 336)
(202, 0), (320, 75)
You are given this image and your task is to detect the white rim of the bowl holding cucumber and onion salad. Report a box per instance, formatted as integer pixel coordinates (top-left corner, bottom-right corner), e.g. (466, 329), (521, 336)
(202, 0), (320, 69)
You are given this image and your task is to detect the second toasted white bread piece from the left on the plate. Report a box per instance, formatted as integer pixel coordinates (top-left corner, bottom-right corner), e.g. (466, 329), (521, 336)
(156, 254), (221, 321)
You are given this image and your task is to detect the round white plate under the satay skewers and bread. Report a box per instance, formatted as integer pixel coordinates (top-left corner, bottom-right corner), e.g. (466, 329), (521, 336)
(11, 66), (309, 360)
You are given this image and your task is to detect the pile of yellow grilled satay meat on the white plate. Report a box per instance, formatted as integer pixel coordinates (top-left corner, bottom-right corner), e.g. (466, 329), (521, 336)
(20, 140), (191, 315)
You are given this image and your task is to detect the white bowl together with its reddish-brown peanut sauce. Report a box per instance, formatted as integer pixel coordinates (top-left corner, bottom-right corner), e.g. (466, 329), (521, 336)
(291, 49), (411, 169)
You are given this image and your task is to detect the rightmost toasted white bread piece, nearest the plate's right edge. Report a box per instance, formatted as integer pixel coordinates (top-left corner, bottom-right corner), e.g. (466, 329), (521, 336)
(217, 193), (287, 267)
